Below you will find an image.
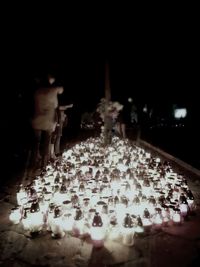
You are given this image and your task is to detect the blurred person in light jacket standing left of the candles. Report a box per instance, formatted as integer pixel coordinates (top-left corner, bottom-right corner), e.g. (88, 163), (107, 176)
(31, 74), (64, 167)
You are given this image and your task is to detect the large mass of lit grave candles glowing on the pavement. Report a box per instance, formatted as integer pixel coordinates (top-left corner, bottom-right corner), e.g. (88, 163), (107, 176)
(10, 137), (195, 246)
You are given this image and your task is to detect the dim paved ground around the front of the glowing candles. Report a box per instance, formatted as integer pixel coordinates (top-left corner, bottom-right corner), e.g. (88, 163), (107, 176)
(0, 133), (200, 267)
